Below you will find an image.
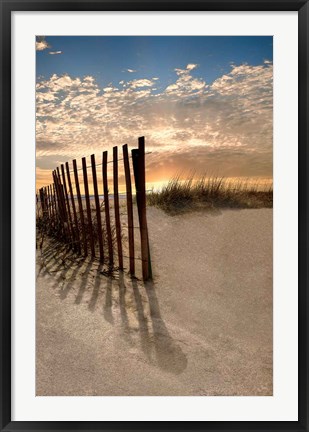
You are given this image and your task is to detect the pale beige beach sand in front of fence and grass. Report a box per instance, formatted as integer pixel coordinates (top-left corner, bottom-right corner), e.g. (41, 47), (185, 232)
(36, 208), (273, 396)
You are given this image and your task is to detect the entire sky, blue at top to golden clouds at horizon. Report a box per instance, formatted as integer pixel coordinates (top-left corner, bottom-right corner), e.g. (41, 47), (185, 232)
(36, 36), (273, 191)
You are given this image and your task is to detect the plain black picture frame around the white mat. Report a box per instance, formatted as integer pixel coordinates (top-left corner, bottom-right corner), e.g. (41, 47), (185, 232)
(0, 0), (309, 431)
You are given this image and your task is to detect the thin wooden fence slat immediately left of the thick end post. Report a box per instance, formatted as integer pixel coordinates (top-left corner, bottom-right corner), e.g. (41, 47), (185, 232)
(122, 144), (135, 275)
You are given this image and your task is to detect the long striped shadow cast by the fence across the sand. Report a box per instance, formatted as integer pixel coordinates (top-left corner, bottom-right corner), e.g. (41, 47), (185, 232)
(37, 247), (187, 375)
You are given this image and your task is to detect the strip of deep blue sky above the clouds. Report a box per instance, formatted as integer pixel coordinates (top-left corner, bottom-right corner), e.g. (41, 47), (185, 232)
(37, 36), (273, 88)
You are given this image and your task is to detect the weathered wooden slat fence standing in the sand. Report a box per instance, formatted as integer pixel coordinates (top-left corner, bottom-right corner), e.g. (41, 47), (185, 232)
(37, 137), (152, 280)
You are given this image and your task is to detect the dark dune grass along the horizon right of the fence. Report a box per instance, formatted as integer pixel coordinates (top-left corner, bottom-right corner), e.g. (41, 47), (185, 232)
(147, 175), (273, 214)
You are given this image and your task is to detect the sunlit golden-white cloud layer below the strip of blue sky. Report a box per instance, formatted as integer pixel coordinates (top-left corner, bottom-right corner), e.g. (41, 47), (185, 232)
(36, 63), (273, 181)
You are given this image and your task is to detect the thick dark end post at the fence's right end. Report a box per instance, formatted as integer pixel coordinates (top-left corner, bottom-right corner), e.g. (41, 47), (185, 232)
(132, 137), (152, 281)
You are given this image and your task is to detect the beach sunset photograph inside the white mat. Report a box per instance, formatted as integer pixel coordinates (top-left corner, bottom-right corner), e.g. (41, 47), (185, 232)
(35, 35), (277, 396)
